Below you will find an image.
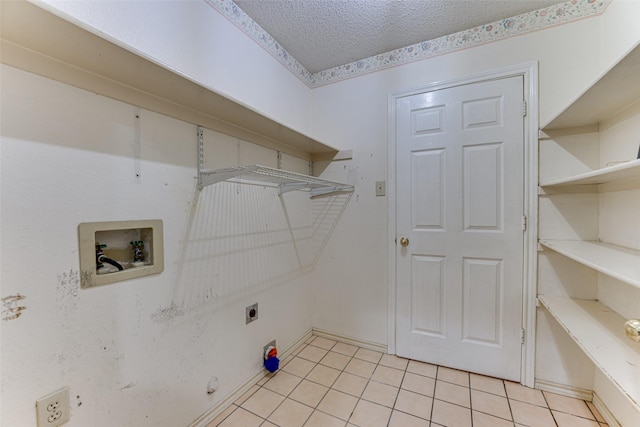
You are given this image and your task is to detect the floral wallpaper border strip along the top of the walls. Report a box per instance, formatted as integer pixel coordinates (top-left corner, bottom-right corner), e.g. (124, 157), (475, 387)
(205, 0), (612, 88)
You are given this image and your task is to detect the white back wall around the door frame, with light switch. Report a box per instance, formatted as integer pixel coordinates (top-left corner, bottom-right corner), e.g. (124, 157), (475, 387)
(313, 1), (640, 383)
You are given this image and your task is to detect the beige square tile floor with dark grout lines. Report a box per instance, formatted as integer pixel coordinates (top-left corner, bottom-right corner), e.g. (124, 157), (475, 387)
(207, 337), (606, 427)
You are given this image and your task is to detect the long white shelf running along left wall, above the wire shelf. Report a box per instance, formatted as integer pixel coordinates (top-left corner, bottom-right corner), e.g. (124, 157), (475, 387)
(0, 1), (338, 160)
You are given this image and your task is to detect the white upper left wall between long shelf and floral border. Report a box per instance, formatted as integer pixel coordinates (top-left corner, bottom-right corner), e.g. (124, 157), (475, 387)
(37, 0), (311, 138)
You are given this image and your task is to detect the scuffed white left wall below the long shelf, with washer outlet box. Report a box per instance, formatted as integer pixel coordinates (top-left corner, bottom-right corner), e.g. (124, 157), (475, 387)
(0, 65), (320, 427)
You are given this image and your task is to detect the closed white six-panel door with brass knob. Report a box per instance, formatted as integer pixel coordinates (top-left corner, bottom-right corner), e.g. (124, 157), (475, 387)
(396, 76), (524, 381)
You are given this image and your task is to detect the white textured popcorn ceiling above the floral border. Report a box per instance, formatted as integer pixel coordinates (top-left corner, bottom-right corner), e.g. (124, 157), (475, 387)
(235, 0), (562, 73)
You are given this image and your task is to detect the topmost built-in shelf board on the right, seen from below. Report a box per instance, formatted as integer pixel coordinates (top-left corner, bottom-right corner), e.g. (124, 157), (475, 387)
(542, 46), (640, 131)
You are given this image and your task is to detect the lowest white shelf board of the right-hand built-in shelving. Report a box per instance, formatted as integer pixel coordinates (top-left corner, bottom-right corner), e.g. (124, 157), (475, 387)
(538, 295), (640, 409)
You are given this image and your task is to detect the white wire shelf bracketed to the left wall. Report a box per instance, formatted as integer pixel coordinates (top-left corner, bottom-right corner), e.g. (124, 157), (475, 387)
(199, 165), (353, 198)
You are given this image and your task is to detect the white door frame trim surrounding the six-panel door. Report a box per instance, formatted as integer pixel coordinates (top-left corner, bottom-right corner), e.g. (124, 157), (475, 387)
(387, 61), (538, 387)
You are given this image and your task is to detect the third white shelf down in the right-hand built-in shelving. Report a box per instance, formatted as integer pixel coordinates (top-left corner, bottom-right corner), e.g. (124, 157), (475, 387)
(540, 240), (640, 288)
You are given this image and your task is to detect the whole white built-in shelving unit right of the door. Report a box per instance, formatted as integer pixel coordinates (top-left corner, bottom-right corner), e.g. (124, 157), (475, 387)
(538, 41), (640, 425)
